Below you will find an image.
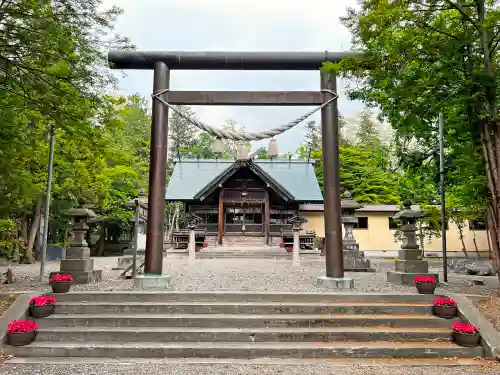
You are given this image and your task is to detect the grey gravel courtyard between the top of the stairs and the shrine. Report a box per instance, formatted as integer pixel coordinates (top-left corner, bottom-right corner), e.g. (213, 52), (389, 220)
(0, 256), (500, 295)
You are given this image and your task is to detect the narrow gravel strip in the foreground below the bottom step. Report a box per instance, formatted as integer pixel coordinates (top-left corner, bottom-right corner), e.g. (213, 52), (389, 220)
(0, 363), (500, 375)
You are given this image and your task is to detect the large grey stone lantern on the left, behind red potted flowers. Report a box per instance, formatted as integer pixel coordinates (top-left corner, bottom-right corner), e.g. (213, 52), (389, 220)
(50, 208), (102, 284)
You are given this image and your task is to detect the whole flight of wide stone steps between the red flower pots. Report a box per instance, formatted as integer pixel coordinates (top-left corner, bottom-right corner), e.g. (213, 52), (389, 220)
(5, 292), (484, 361)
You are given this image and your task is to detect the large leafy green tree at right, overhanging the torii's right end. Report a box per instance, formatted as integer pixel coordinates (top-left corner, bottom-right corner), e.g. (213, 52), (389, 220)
(325, 0), (500, 274)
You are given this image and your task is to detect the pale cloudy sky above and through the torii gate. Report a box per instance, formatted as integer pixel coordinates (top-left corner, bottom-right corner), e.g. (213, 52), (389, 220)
(103, 0), (362, 153)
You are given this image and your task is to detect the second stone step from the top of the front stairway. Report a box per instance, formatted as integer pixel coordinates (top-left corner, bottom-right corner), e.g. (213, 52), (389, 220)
(54, 301), (432, 315)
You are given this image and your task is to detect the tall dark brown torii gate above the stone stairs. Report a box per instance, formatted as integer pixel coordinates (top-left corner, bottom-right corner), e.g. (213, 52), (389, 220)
(108, 51), (358, 287)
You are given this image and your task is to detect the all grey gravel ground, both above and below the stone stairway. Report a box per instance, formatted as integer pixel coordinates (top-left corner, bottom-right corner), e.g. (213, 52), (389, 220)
(0, 256), (500, 375)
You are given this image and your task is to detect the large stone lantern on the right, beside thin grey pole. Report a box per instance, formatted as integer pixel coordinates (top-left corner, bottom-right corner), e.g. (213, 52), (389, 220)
(387, 200), (439, 285)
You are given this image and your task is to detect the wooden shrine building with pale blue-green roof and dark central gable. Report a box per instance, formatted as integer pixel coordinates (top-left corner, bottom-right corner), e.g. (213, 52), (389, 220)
(167, 160), (322, 244)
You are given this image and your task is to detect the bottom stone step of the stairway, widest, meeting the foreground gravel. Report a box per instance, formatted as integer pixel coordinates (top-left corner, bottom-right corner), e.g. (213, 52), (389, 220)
(5, 341), (484, 359)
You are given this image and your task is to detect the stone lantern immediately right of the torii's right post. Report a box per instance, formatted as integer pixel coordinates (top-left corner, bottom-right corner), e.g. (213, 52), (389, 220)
(341, 191), (371, 272)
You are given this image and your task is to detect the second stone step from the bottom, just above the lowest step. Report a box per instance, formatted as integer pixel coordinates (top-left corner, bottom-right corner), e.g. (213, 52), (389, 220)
(36, 327), (452, 343)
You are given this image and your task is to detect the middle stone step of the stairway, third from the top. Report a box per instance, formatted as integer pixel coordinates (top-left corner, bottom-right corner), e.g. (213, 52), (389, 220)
(37, 314), (456, 328)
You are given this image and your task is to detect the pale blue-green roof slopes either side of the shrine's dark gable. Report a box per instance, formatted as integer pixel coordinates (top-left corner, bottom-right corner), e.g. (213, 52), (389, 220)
(166, 159), (323, 202)
